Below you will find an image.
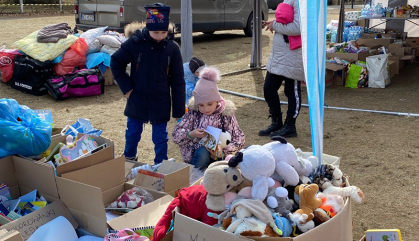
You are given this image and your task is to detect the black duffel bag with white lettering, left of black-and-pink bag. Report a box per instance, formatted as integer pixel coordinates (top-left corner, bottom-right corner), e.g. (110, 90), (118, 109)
(10, 56), (53, 96)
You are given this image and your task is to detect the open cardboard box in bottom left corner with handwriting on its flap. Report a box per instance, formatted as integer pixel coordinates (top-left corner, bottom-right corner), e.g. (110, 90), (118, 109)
(0, 156), (77, 240)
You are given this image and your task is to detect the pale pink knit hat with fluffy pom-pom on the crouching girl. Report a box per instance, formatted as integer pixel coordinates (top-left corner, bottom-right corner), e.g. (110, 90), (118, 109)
(193, 66), (221, 104)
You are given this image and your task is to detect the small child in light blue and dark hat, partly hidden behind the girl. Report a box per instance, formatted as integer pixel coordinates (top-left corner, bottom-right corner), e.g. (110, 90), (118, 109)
(183, 57), (205, 106)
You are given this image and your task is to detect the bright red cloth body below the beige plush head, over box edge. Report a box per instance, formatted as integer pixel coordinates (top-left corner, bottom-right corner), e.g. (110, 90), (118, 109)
(153, 185), (221, 241)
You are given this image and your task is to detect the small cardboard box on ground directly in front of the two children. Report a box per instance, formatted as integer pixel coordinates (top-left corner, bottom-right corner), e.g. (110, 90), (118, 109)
(133, 160), (190, 197)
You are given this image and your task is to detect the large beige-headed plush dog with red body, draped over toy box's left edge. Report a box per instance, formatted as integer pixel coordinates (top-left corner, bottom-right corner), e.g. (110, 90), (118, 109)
(153, 161), (243, 241)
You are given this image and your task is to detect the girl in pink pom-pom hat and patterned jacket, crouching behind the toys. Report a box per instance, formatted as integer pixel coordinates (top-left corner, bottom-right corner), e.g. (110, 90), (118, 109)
(172, 67), (245, 169)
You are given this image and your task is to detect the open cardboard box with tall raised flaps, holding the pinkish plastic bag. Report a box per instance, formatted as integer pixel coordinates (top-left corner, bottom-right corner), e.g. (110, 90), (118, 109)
(56, 157), (173, 237)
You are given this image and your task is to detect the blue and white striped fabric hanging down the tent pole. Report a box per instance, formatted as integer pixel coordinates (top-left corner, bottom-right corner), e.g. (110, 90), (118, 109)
(298, 0), (327, 164)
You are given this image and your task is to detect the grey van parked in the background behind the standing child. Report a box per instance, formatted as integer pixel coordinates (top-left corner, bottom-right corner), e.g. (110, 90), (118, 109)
(74, 0), (269, 36)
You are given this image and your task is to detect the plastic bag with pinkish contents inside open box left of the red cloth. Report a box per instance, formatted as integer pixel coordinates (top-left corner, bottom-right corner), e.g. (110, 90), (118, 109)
(108, 187), (154, 209)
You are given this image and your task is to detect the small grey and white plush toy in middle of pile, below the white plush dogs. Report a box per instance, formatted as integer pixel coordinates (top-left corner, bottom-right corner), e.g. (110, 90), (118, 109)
(266, 187), (292, 217)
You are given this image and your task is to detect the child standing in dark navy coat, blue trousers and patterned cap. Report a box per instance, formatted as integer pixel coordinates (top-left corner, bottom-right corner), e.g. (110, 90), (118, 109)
(111, 3), (185, 164)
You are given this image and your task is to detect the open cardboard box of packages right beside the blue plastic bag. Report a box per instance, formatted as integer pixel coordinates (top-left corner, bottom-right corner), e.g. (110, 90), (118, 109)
(36, 133), (114, 177)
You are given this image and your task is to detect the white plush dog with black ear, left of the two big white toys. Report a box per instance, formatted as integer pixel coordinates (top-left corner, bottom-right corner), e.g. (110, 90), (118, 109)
(228, 146), (275, 201)
